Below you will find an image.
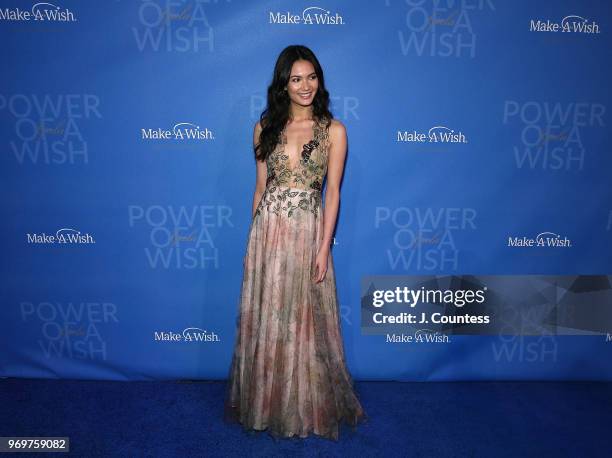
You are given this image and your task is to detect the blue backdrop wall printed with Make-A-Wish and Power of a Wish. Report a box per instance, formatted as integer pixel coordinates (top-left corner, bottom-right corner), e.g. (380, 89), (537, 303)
(0, 0), (612, 381)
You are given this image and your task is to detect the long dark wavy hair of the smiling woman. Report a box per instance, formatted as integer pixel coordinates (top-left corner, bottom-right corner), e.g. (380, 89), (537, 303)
(254, 45), (333, 161)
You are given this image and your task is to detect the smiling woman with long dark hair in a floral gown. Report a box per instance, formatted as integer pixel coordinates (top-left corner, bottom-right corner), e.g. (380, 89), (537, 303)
(226, 45), (365, 439)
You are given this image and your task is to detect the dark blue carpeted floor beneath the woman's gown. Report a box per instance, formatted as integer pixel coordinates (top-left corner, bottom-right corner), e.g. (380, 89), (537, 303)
(0, 378), (612, 458)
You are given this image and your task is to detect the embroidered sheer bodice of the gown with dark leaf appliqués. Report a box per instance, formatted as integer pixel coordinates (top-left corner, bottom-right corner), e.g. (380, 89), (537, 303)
(266, 119), (329, 192)
